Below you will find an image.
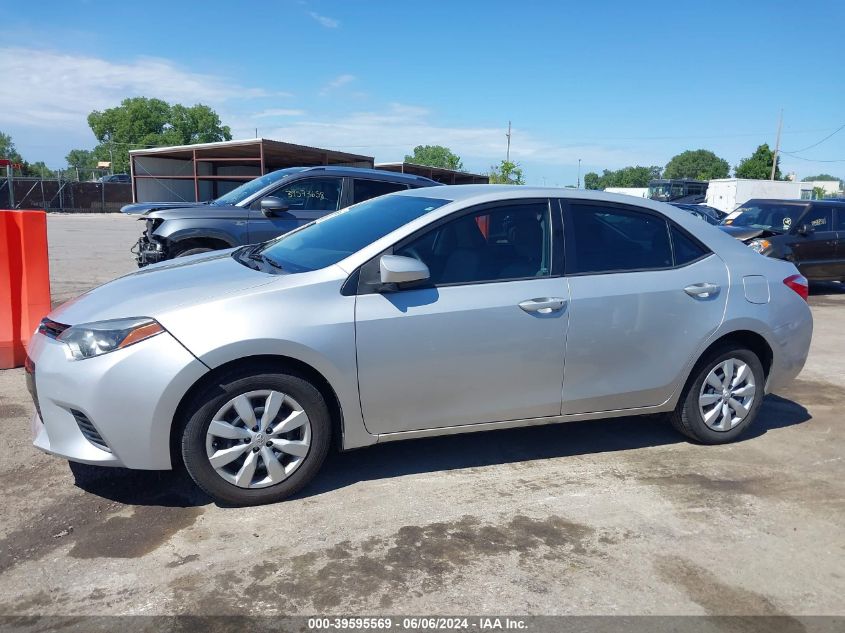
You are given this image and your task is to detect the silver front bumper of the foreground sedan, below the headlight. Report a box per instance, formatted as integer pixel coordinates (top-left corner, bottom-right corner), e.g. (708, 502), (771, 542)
(29, 332), (208, 470)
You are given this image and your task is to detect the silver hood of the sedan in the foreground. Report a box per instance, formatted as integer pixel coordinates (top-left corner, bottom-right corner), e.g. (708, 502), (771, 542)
(50, 249), (279, 325)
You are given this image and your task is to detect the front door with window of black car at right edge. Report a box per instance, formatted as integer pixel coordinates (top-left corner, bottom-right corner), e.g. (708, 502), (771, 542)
(790, 202), (842, 279)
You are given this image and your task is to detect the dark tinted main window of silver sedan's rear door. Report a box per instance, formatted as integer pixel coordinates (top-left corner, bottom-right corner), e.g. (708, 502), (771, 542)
(566, 204), (672, 273)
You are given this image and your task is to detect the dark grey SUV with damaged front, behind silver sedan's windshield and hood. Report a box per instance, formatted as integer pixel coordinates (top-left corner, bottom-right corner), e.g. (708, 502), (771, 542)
(130, 167), (440, 266)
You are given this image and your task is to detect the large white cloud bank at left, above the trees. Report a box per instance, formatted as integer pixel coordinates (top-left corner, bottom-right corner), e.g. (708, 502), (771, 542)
(0, 47), (269, 129)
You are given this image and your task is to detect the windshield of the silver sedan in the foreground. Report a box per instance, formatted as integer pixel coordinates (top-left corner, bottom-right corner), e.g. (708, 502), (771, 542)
(254, 194), (450, 273)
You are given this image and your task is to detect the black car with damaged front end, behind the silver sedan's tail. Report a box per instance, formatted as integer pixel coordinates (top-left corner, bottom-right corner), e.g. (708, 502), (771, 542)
(720, 199), (845, 281)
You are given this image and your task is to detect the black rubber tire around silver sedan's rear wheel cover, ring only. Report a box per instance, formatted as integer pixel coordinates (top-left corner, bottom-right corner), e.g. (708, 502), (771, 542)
(669, 345), (766, 444)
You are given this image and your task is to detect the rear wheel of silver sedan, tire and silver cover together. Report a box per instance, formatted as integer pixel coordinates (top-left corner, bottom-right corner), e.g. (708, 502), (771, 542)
(670, 347), (765, 444)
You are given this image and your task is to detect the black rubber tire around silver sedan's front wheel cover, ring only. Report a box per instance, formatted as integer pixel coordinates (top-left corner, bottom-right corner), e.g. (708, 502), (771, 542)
(181, 368), (332, 506)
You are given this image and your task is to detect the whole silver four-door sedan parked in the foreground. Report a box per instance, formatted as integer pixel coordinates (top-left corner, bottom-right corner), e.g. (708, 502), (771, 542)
(27, 185), (812, 505)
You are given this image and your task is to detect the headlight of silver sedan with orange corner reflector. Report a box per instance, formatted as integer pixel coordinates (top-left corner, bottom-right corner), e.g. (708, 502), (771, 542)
(57, 317), (164, 360)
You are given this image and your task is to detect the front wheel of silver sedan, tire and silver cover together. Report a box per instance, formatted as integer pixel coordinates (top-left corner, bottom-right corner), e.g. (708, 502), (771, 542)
(182, 372), (331, 506)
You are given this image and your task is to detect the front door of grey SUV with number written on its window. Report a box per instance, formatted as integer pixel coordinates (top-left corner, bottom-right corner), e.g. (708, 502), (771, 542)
(249, 176), (343, 244)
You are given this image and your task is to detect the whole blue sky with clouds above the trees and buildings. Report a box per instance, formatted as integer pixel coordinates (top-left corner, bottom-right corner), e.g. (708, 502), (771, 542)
(0, 0), (845, 186)
